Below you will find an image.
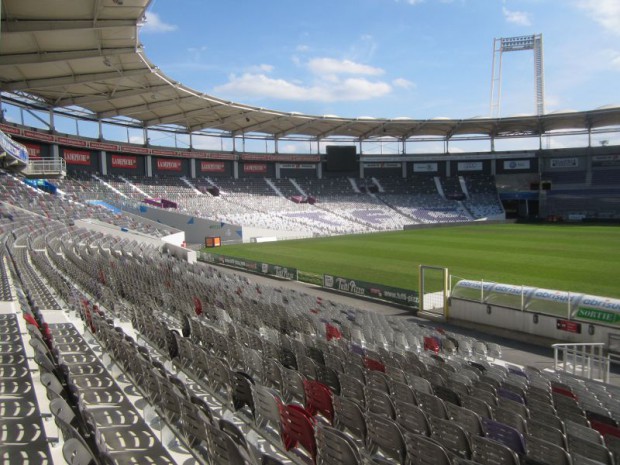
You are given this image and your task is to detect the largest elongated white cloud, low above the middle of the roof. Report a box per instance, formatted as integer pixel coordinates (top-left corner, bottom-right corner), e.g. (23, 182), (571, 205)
(214, 73), (392, 102)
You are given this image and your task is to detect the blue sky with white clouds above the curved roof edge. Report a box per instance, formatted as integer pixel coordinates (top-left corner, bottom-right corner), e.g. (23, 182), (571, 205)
(140, 0), (620, 118)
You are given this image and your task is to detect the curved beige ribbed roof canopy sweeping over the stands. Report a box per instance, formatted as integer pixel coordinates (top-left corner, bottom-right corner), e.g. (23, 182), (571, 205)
(0, 0), (620, 140)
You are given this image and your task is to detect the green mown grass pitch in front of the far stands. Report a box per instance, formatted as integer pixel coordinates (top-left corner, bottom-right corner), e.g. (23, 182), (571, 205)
(211, 224), (620, 298)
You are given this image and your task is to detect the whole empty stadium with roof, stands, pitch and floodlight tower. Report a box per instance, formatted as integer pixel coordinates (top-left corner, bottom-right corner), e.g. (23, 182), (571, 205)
(0, 0), (620, 465)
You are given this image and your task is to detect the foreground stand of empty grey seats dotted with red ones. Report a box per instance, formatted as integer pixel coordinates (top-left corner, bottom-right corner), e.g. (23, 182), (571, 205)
(0, 169), (620, 465)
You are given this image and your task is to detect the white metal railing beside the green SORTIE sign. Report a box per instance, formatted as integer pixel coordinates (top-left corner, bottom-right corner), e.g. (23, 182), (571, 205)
(551, 342), (620, 383)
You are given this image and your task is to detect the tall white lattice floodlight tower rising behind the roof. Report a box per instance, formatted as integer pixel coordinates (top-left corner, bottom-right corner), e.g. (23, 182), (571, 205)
(491, 34), (545, 118)
